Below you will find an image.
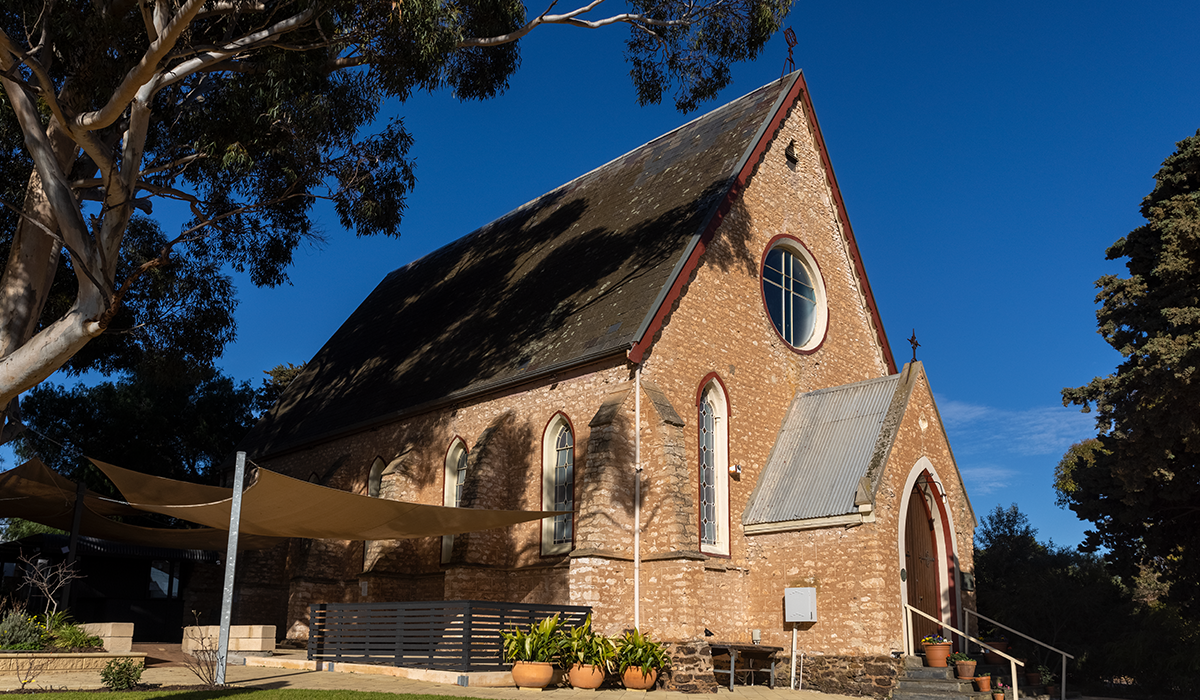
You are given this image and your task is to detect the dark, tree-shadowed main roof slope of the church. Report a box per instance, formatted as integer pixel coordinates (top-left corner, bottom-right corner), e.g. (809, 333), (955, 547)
(240, 74), (797, 456)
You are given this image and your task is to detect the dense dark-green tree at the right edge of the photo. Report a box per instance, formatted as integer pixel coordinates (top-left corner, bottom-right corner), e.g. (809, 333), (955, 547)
(1056, 131), (1200, 620)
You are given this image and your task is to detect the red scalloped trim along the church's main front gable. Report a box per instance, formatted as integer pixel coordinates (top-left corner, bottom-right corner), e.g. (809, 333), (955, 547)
(629, 72), (896, 375)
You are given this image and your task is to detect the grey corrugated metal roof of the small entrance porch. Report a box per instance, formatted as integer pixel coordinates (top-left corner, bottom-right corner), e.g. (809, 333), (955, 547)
(742, 365), (914, 527)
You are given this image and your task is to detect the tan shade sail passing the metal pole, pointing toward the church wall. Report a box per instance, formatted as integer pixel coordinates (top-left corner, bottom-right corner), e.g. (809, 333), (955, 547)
(91, 460), (570, 539)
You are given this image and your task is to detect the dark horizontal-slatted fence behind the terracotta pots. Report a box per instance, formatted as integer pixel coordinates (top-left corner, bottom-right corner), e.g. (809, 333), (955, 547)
(308, 600), (592, 672)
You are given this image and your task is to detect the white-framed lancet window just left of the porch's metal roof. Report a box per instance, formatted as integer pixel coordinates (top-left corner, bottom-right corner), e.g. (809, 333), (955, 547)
(696, 376), (730, 556)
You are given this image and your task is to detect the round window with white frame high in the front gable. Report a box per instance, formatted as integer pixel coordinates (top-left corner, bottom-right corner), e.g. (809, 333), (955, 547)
(762, 239), (828, 351)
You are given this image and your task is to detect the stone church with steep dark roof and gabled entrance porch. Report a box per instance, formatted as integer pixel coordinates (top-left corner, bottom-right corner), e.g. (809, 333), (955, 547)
(238, 72), (976, 692)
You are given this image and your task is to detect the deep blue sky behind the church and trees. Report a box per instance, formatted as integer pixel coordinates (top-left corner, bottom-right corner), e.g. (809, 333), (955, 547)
(9, 0), (1200, 552)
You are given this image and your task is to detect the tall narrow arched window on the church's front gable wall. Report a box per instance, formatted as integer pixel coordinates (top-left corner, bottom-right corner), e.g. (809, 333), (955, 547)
(696, 375), (730, 555)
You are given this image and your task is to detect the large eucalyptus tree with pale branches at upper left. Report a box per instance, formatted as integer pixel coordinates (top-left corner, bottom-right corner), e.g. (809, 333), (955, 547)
(0, 0), (790, 439)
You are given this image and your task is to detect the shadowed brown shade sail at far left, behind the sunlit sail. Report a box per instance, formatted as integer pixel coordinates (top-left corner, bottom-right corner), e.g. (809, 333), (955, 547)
(0, 459), (281, 550)
